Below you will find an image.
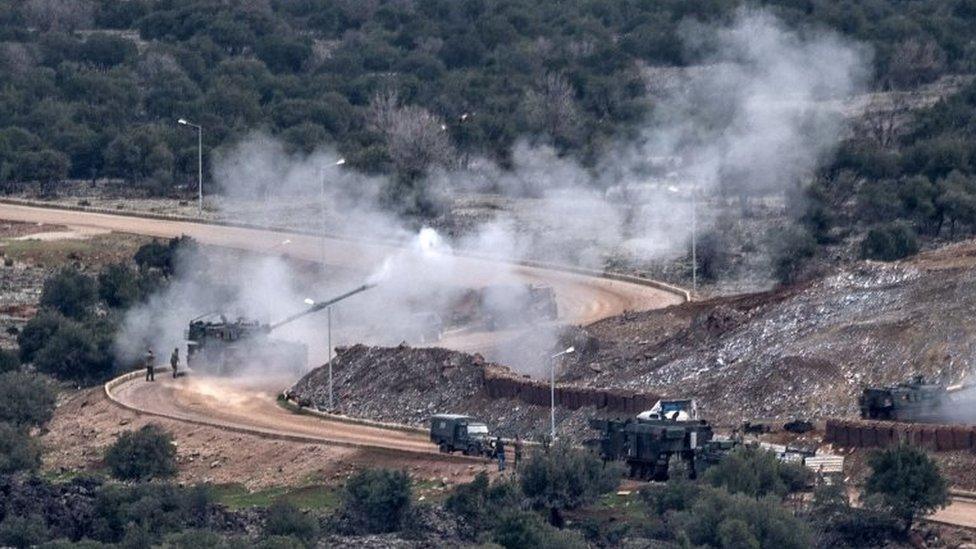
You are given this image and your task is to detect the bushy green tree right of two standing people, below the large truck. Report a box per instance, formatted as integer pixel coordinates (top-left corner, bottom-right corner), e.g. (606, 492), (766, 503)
(519, 443), (621, 526)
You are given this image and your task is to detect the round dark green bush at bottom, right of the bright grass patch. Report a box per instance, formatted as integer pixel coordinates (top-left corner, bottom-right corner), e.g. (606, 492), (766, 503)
(342, 469), (411, 533)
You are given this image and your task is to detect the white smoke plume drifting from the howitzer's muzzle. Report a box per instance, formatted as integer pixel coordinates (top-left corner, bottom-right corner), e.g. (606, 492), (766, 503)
(119, 10), (869, 373)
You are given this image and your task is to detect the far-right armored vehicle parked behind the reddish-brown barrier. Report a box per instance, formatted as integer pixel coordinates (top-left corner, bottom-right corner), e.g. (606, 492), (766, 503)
(858, 376), (960, 423)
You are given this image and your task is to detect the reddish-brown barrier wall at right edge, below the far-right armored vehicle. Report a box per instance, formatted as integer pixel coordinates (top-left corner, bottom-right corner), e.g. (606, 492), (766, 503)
(824, 419), (976, 452)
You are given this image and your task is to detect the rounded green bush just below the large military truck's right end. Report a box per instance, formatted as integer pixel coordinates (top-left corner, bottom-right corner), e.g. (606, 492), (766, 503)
(704, 446), (810, 498)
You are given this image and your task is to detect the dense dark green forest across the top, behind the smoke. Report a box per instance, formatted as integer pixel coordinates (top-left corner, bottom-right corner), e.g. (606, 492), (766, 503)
(0, 0), (976, 191)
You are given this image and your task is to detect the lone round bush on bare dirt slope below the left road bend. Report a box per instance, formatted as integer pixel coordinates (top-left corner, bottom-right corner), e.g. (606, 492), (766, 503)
(105, 424), (176, 480)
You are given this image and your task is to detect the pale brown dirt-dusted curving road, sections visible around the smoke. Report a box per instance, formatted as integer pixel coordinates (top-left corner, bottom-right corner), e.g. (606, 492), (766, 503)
(0, 203), (684, 458)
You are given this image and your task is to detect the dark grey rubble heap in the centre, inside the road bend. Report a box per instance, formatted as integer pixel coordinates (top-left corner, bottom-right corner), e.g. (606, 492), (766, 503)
(287, 345), (628, 441)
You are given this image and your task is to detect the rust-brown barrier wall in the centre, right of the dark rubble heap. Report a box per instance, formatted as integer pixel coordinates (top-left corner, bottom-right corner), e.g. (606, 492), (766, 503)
(484, 370), (661, 414)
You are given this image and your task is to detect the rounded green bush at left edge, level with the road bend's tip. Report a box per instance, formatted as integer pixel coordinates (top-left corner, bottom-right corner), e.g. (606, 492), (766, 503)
(0, 372), (57, 428)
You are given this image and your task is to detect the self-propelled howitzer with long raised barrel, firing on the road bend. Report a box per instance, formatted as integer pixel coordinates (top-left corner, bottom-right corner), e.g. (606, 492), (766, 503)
(186, 284), (372, 375)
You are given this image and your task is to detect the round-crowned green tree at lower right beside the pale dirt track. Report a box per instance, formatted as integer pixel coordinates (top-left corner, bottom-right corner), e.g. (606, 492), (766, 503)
(864, 445), (949, 531)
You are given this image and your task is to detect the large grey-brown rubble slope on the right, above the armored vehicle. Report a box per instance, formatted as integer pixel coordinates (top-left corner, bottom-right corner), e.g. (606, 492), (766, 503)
(567, 255), (976, 425)
